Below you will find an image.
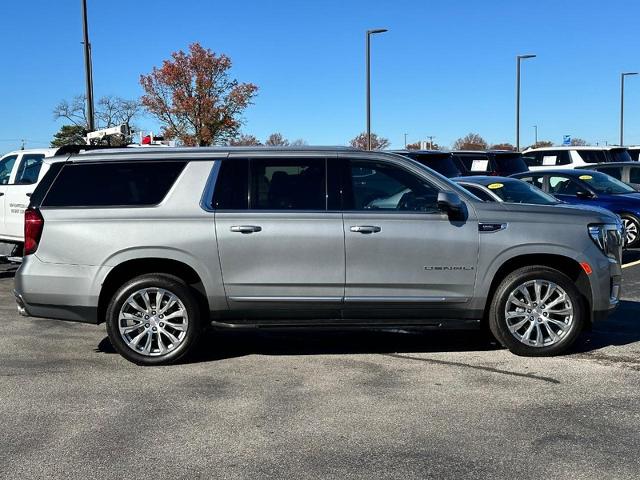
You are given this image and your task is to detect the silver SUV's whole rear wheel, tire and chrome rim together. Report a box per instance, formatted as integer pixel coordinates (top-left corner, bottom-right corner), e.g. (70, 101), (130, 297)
(106, 274), (200, 365)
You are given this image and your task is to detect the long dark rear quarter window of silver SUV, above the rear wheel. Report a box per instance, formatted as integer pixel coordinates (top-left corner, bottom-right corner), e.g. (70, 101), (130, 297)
(42, 162), (186, 207)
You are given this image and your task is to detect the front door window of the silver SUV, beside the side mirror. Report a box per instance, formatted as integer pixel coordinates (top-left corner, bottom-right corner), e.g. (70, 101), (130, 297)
(343, 160), (440, 213)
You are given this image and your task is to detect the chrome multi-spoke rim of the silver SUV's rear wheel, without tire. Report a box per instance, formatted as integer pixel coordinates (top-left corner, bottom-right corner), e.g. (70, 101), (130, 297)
(118, 287), (189, 357)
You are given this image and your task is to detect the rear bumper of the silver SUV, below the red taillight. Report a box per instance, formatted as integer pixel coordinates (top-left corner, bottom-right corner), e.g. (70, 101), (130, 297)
(14, 255), (99, 324)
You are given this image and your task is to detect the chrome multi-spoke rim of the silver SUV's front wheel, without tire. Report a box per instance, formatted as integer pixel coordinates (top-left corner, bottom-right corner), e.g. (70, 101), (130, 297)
(504, 280), (574, 347)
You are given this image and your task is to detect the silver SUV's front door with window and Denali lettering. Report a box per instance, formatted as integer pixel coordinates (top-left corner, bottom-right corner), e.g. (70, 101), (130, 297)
(342, 159), (479, 319)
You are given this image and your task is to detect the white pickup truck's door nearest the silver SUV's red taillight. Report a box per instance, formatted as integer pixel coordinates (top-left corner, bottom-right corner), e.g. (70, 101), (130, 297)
(5, 153), (44, 240)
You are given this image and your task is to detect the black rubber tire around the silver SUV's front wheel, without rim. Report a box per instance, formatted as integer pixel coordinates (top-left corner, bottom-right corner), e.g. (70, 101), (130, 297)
(489, 265), (587, 357)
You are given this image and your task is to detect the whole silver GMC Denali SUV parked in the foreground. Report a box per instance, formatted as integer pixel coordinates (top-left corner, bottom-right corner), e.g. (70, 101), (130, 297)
(15, 148), (622, 365)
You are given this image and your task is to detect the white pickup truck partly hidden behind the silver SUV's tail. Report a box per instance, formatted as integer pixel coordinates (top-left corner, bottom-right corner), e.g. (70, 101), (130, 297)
(0, 148), (58, 255)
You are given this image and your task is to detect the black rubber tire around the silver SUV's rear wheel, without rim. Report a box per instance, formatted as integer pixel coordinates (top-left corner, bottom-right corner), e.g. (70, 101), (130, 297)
(106, 274), (202, 366)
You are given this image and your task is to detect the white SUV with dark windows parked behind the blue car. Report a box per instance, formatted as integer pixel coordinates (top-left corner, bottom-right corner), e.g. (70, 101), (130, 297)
(522, 146), (632, 170)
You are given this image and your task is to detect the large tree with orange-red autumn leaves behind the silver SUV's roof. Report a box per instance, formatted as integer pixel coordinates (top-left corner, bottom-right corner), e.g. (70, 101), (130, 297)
(140, 43), (258, 146)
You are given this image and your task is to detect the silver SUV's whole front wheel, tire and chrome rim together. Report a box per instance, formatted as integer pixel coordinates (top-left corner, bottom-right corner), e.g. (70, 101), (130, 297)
(489, 266), (586, 356)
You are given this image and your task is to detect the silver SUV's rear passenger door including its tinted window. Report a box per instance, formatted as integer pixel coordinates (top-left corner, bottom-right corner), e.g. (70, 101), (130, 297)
(214, 156), (345, 320)
